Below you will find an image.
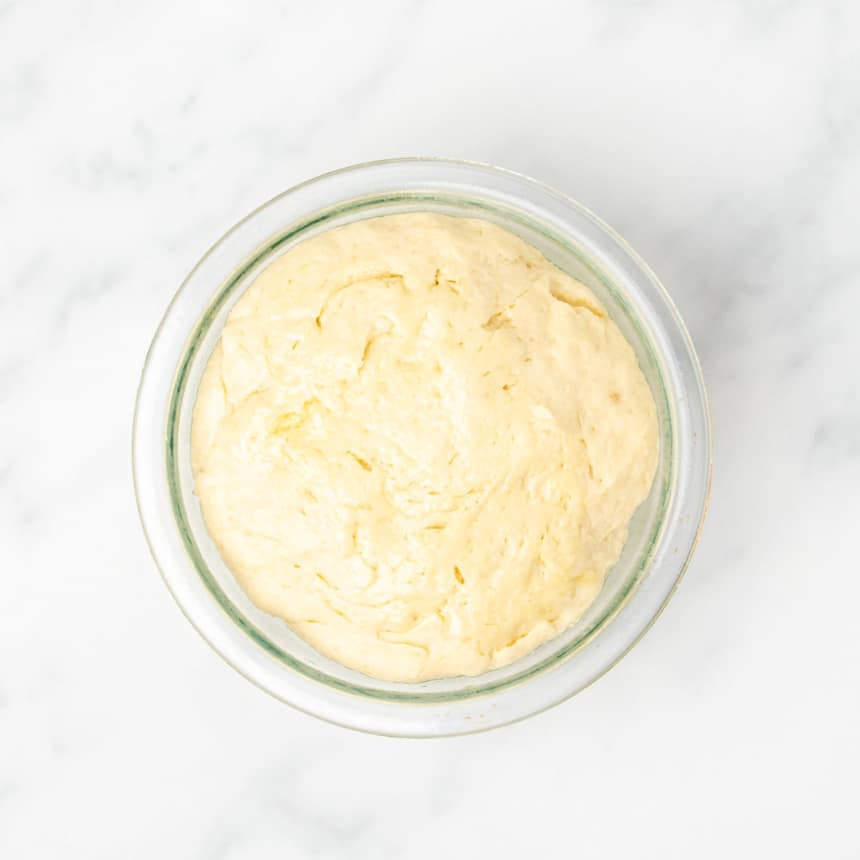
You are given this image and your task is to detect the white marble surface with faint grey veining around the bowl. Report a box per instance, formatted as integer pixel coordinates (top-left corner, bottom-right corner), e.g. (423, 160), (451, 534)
(0, 0), (860, 860)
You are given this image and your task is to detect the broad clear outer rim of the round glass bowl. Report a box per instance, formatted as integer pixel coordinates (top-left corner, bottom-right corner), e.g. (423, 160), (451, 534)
(132, 157), (712, 736)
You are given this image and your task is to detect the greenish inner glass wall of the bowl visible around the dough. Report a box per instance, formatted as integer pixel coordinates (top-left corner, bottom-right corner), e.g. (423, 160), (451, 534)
(167, 191), (675, 702)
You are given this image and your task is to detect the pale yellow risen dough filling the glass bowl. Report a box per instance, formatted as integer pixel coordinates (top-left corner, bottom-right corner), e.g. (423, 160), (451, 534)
(192, 213), (658, 681)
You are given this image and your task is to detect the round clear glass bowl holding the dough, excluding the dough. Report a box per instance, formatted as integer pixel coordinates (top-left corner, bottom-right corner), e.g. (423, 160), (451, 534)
(133, 159), (711, 736)
